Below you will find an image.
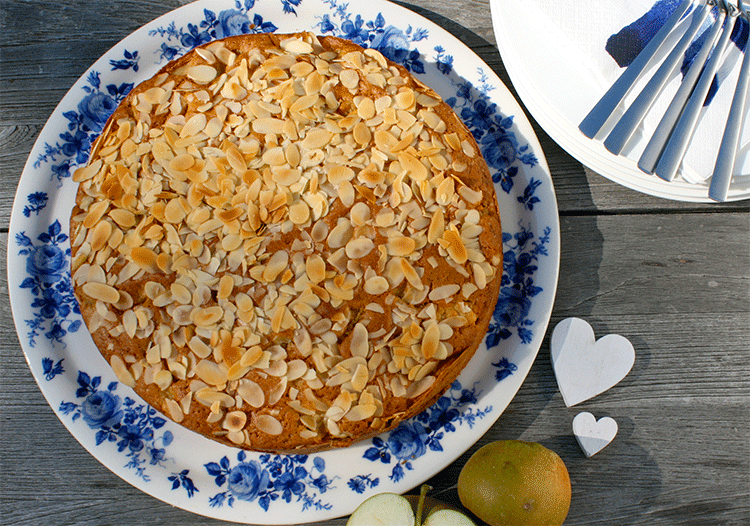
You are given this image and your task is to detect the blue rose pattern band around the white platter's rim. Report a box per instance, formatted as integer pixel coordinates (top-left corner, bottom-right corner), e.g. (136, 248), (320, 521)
(9, 0), (556, 522)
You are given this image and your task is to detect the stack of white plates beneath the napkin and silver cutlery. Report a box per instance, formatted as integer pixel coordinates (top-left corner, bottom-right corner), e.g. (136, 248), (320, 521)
(491, 0), (750, 202)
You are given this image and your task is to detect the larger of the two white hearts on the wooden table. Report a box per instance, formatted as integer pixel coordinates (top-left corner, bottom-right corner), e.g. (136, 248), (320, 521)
(550, 318), (635, 407)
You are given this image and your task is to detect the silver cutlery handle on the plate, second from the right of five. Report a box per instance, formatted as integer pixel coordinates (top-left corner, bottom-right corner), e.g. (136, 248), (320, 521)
(654, 11), (737, 181)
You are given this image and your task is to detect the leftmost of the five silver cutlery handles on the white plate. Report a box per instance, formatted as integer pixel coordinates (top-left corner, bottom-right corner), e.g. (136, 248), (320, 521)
(578, 0), (705, 139)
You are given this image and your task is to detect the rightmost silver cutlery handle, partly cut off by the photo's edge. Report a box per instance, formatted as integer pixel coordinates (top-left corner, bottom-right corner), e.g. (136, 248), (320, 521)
(708, 33), (750, 201)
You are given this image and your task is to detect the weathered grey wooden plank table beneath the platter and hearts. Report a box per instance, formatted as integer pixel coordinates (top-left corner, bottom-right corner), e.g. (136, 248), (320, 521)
(0, 0), (750, 526)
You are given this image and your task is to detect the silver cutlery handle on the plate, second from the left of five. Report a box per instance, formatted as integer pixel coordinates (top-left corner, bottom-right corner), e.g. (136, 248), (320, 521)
(604, 6), (720, 155)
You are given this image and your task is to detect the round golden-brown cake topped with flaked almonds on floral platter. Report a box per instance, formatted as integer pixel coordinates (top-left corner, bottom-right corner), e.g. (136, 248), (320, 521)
(71, 33), (502, 452)
